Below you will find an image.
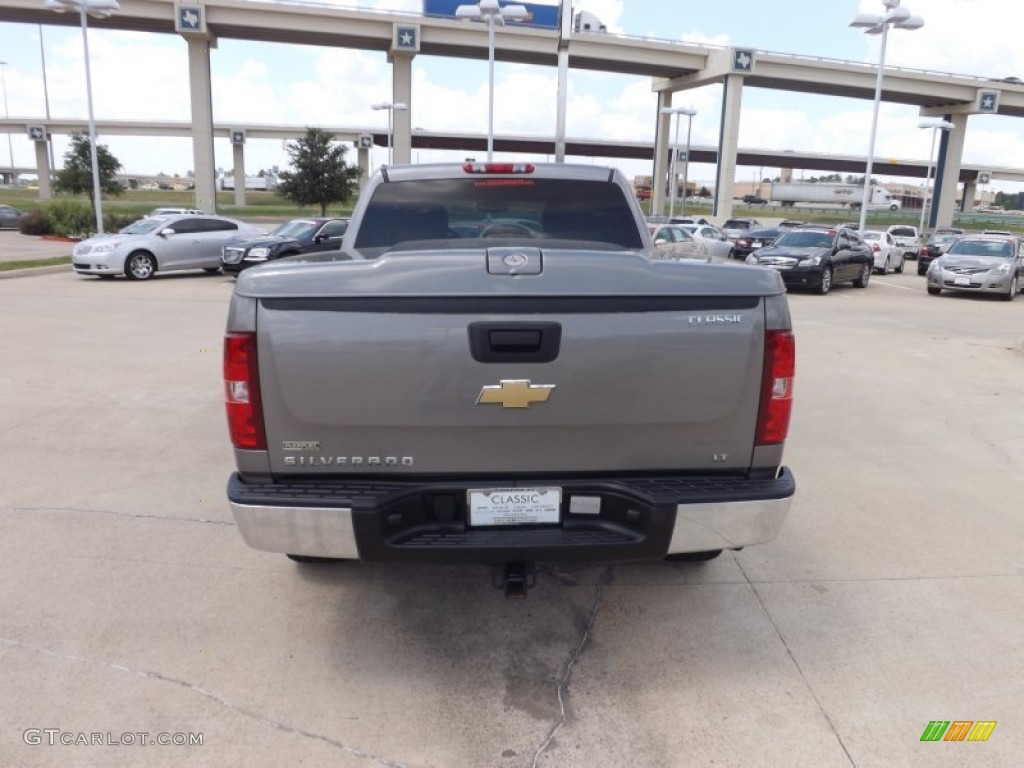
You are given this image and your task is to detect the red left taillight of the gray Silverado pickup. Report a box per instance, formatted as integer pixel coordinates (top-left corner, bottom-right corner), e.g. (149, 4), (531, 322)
(224, 333), (266, 451)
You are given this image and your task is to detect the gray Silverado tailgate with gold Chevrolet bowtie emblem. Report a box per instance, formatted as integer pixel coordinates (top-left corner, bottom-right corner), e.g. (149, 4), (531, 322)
(249, 254), (765, 475)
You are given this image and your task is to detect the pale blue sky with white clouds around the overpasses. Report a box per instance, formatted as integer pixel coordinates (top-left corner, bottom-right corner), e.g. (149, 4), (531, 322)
(0, 0), (1024, 191)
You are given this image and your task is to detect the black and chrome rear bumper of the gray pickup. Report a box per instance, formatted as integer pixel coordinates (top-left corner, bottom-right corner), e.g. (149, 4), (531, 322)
(227, 468), (796, 563)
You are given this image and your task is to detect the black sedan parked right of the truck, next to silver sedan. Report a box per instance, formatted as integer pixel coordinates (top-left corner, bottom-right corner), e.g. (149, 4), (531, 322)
(746, 227), (874, 294)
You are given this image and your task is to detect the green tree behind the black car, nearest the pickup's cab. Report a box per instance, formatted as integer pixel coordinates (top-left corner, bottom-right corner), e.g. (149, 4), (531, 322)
(278, 128), (359, 216)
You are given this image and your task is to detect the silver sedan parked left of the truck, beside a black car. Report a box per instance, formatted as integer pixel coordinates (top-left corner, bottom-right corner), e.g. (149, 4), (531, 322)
(72, 214), (263, 280)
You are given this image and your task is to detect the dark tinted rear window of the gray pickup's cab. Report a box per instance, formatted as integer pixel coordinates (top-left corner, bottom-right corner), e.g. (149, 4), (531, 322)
(354, 176), (644, 257)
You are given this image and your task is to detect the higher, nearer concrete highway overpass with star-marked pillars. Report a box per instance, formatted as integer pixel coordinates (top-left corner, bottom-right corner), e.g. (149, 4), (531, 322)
(0, 0), (1024, 222)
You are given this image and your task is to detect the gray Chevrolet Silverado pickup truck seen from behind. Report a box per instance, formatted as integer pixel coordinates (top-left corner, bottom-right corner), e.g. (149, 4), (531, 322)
(224, 163), (796, 596)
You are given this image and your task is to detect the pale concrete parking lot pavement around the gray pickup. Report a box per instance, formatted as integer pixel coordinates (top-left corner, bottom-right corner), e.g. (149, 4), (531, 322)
(0, 265), (1024, 768)
